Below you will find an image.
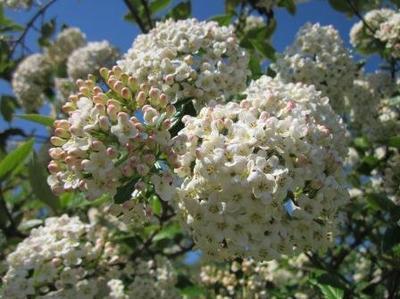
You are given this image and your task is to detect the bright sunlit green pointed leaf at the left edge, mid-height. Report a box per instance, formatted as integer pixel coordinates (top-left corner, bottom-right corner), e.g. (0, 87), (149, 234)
(0, 139), (34, 180)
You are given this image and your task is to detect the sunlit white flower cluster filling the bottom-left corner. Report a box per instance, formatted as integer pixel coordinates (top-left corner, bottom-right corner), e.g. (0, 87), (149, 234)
(3, 215), (121, 299)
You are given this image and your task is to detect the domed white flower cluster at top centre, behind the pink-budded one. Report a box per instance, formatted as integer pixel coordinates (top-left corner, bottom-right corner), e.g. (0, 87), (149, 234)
(118, 19), (248, 107)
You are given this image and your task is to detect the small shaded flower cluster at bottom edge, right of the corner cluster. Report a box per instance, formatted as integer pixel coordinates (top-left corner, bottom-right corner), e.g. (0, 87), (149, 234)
(108, 257), (181, 299)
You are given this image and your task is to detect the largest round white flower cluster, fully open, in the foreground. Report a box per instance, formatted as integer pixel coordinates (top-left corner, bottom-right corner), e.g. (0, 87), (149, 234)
(174, 76), (347, 260)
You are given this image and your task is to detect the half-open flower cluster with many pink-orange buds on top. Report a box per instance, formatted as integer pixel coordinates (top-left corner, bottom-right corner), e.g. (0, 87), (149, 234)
(48, 67), (175, 199)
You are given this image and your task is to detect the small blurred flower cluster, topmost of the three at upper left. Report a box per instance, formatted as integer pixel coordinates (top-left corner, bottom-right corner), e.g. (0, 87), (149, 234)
(46, 27), (87, 65)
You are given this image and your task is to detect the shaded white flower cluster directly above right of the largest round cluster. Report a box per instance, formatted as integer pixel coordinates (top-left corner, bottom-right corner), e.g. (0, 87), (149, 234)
(272, 23), (356, 113)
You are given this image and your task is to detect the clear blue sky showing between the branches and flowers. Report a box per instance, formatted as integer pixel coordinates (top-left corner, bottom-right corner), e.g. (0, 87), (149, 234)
(0, 0), (377, 135)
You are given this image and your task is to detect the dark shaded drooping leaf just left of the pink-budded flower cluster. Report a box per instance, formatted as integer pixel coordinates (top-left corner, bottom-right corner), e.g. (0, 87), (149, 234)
(28, 153), (60, 211)
